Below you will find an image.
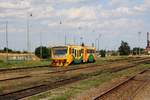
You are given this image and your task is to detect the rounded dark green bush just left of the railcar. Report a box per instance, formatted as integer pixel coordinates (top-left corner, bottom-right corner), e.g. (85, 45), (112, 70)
(35, 46), (51, 59)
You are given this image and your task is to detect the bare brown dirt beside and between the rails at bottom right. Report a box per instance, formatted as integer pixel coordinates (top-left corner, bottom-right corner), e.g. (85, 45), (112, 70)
(71, 71), (150, 100)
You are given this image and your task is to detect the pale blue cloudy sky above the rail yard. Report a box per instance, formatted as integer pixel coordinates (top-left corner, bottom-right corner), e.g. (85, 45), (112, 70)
(0, 0), (150, 50)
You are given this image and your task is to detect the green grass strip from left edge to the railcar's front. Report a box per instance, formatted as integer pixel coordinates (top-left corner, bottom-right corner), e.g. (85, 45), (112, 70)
(0, 60), (50, 68)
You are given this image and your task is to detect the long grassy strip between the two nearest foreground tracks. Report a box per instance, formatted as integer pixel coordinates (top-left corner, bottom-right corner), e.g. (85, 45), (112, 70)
(28, 64), (150, 100)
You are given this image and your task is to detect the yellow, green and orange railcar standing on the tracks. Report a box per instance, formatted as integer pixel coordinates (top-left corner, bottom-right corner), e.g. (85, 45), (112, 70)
(51, 45), (96, 66)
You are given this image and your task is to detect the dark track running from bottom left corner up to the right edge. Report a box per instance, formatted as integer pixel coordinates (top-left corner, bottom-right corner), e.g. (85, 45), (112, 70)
(0, 59), (149, 100)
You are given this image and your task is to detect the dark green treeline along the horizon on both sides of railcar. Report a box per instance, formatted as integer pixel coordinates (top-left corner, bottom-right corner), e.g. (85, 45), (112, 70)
(0, 41), (148, 59)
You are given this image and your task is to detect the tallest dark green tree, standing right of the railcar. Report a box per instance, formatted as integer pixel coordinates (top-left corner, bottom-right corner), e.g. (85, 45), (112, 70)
(118, 41), (130, 55)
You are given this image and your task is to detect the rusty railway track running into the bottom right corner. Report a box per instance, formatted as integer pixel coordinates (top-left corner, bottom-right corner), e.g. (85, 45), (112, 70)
(93, 69), (150, 100)
